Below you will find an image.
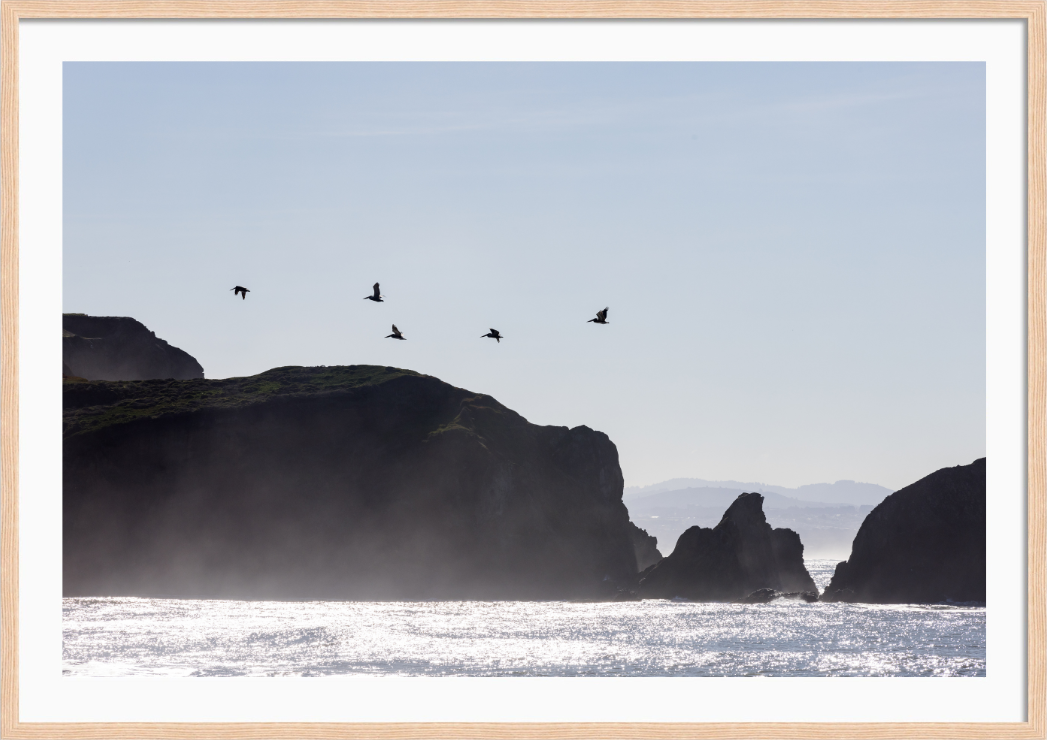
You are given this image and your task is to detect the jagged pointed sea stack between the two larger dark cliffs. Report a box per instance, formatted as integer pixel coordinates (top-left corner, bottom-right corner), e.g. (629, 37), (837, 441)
(638, 493), (818, 601)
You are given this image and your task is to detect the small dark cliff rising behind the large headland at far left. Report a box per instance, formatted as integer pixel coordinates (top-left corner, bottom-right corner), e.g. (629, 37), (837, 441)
(62, 314), (203, 380)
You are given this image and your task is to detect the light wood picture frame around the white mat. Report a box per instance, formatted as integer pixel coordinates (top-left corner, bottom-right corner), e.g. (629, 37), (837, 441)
(0, 0), (1047, 740)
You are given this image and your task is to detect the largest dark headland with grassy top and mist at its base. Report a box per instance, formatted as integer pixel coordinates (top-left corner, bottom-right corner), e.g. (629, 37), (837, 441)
(63, 366), (636, 600)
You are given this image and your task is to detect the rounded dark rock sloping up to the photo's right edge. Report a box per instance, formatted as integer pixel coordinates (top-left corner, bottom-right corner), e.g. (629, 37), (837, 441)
(822, 457), (985, 604)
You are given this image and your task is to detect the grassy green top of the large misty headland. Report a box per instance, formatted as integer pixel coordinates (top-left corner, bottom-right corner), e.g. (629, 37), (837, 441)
(63, 365), (426, 438)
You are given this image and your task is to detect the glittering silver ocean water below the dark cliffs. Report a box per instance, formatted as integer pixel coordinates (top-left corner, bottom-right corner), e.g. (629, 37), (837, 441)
(63, 560), (985, 676)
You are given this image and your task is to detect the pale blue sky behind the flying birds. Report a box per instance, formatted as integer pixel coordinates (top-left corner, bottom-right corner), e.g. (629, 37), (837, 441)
(63, 62), (985, 489)
